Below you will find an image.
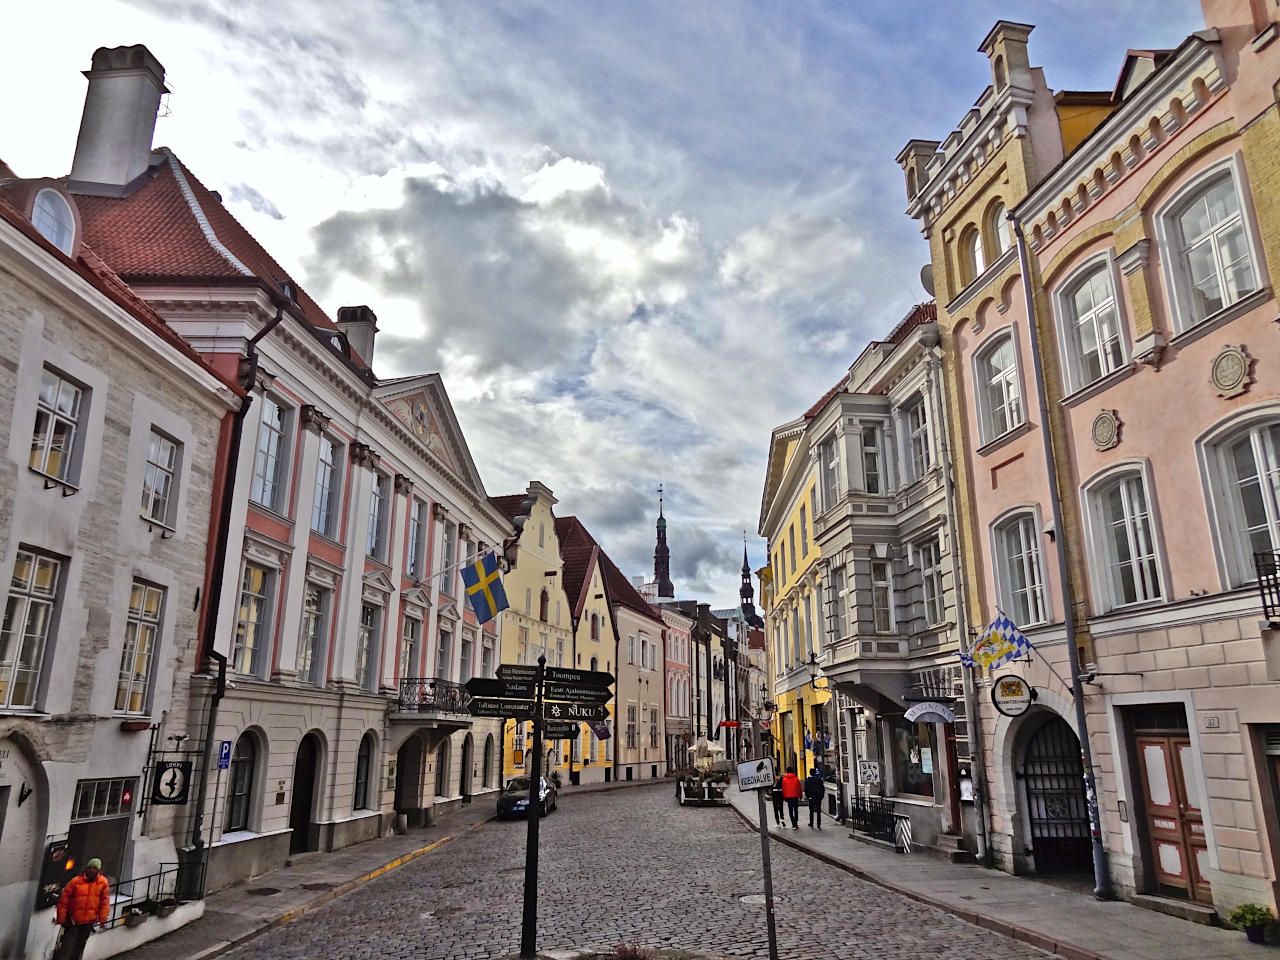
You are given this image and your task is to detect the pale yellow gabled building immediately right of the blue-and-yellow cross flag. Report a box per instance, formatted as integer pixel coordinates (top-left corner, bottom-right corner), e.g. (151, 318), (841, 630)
(490, 480), (575, 780)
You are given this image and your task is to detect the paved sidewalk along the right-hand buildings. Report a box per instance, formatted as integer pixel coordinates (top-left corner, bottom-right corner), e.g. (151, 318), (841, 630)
(726, 785), (1267, 960)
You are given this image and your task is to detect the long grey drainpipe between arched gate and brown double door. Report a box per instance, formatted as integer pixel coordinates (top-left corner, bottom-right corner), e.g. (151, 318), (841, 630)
(1009, 214), (1112, 900)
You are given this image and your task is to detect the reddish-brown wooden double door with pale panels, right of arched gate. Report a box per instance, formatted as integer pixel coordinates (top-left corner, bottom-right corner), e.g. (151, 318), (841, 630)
(1135, 735), (1212, 902)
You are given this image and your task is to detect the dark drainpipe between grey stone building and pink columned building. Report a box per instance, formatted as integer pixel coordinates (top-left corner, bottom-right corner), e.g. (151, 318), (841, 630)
(191, 297), (284, 880)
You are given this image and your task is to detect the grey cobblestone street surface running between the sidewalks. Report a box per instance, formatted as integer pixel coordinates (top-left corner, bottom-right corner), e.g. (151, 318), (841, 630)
(227, 787), (1047, 960)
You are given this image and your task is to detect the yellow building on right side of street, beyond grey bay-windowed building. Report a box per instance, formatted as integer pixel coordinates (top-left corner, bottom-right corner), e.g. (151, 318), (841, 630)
(759, 414), (836, 777)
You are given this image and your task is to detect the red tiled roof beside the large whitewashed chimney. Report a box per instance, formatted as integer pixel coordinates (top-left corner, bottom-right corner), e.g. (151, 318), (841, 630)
(76, 147), (355, 355)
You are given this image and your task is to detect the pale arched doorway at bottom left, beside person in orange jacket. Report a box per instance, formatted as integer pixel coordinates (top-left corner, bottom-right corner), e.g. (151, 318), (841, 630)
(0, 737), (49, 957)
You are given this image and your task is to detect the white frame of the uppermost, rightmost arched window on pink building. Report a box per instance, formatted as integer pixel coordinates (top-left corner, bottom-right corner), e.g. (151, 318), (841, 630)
(1153, 151), (1267, 337)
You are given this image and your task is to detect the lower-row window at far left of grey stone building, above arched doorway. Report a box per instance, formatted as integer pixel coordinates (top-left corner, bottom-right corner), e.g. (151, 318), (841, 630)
(0, 549), (63, 708)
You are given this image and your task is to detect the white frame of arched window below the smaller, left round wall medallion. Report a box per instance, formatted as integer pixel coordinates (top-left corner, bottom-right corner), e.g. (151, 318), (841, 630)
(1080, 460), (1170, 613)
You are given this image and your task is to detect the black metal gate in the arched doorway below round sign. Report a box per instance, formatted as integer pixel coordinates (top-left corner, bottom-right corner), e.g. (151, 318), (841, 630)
(1019, 717), (1093, 873)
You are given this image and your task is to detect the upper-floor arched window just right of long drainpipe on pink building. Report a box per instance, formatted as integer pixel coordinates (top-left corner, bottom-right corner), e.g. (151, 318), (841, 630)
(1055, 261), (1125, 393)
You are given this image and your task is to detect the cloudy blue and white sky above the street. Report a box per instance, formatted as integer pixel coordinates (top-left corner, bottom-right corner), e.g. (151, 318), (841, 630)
(0, 0), (1203, 605)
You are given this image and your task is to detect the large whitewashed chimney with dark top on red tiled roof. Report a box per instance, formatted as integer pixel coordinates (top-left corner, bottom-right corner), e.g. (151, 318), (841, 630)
(70, 44), (169, 197)
